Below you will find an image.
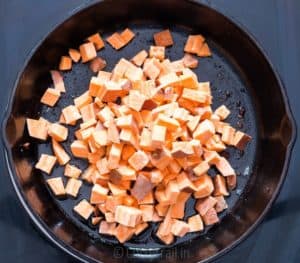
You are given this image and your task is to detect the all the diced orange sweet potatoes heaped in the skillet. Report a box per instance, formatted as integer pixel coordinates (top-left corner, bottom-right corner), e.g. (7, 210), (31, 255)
(27, 29), (251, 244)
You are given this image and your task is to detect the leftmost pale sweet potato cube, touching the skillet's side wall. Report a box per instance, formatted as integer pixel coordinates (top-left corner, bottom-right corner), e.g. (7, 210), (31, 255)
(26, 118), (49, 141)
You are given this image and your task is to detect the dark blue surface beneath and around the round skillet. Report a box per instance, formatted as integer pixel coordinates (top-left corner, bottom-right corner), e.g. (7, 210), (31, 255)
(0, 0), (300, 263)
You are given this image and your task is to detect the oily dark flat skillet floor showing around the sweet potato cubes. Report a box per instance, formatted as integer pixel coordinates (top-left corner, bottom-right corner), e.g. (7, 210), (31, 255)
(34, 23), (257, 249)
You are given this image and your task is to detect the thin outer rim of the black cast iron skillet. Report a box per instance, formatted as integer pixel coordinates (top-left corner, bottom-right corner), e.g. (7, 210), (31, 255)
(1, 0), (297, 262)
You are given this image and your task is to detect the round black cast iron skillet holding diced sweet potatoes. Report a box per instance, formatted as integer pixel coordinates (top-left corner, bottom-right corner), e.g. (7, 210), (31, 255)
(3, 0), (295, 262)
